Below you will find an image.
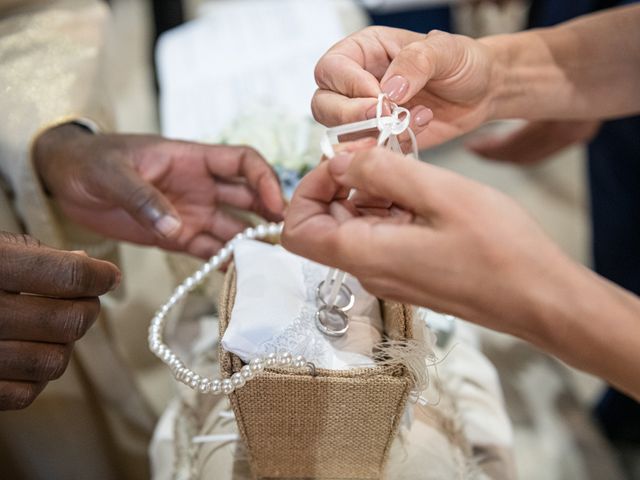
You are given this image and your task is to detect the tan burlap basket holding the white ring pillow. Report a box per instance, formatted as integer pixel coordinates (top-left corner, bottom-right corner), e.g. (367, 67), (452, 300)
(219, 267), (412, 480)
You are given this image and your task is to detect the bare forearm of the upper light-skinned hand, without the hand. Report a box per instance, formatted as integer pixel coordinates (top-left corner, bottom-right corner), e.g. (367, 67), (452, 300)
(480, 5), (640, 120)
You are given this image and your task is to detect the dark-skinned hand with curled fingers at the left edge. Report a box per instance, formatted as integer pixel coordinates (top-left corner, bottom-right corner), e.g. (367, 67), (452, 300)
(0, 232), (120, 410)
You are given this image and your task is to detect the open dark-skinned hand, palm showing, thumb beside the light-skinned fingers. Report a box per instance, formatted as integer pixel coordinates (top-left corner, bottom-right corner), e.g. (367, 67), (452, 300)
(34, 124), (284, 258)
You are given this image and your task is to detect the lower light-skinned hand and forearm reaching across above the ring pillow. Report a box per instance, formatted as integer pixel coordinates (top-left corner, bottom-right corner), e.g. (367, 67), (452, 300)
(282, 148), (640, 399)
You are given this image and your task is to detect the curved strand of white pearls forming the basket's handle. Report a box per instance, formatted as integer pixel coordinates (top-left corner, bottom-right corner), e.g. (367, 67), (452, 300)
(148, 223), (315, 395)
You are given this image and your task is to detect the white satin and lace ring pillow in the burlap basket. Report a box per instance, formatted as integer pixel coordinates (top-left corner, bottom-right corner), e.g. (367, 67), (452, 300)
(222, 240), (382, 370)
